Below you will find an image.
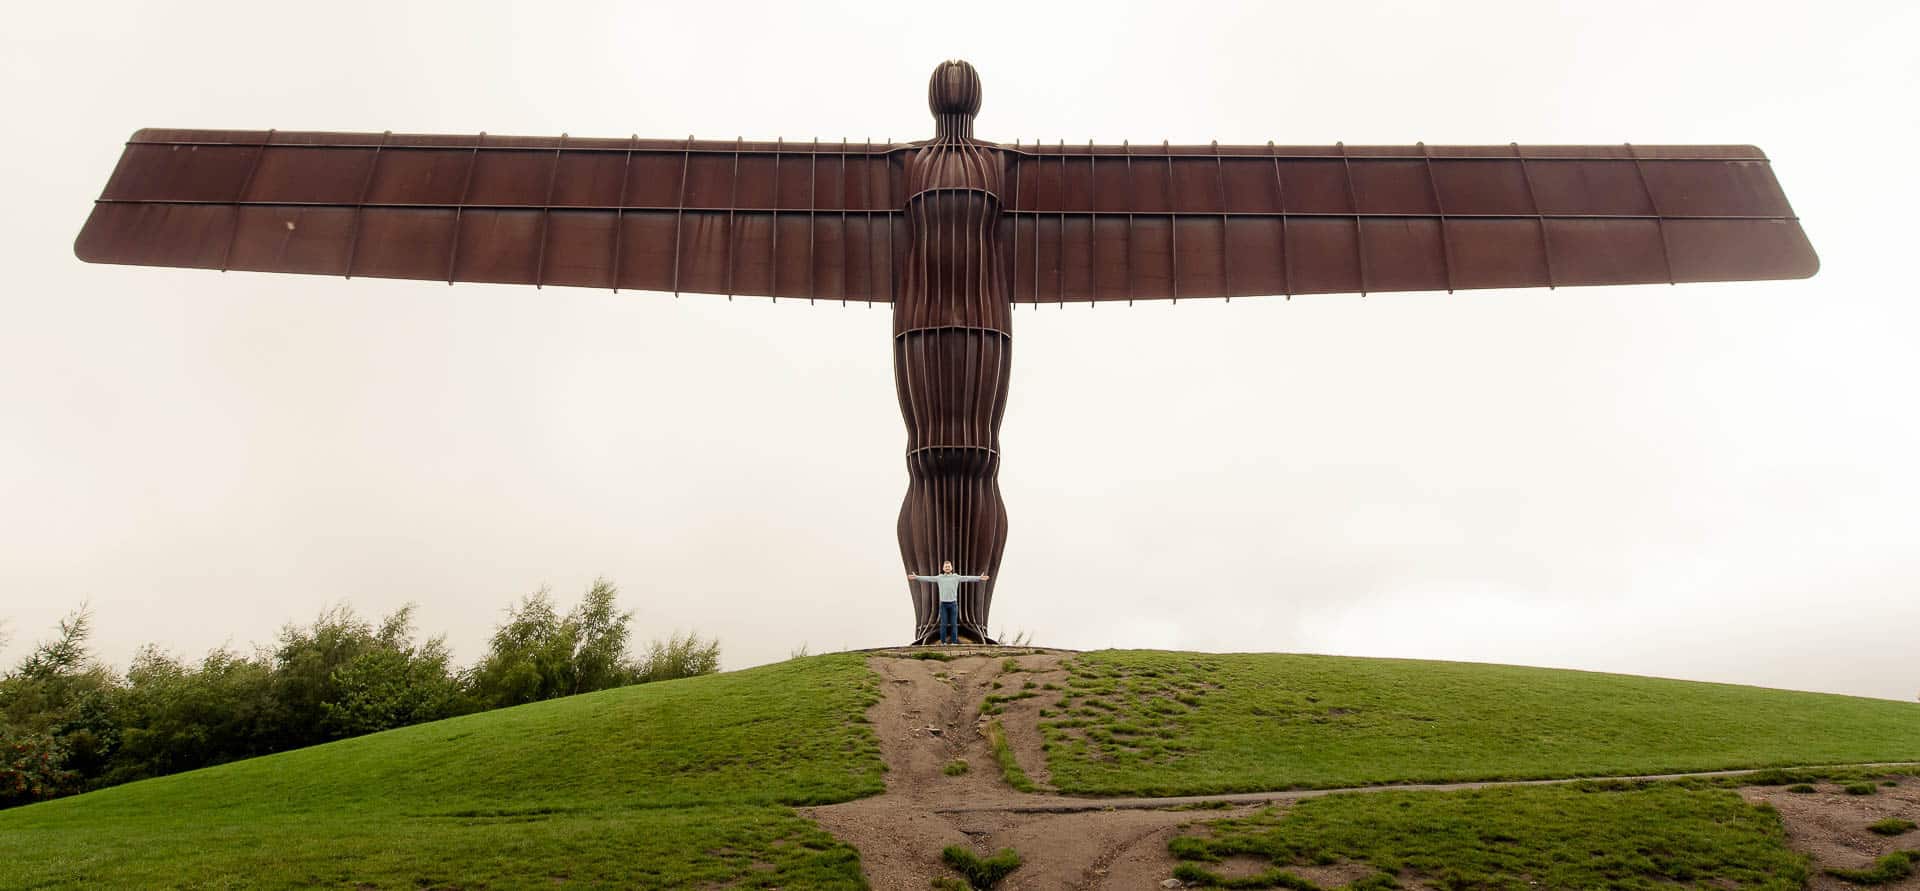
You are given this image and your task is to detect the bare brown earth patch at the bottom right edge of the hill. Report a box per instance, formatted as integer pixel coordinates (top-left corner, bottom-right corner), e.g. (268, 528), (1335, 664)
(1740, 776), (1920, 891)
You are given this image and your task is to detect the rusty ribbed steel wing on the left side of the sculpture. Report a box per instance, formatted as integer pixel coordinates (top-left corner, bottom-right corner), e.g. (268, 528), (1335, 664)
(73, 131), (906, 301)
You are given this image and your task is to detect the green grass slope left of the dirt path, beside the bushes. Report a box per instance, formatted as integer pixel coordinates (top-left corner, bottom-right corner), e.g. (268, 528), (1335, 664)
(0, 655), (883, 889)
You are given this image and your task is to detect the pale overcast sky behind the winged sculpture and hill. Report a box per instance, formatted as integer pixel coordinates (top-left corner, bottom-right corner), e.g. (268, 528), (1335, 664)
(0, 0), (1920, 699)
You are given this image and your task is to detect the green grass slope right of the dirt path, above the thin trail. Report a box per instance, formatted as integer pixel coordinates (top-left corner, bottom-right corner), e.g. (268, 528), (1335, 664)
(1041, 651), (1920, 795)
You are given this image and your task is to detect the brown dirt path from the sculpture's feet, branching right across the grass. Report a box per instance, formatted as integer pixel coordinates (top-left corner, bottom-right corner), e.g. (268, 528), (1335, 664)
(801, 647), (1920, 891)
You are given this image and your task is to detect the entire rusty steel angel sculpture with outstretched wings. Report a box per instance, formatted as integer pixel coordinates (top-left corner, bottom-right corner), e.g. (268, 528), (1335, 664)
(75, 61), (1818, 641)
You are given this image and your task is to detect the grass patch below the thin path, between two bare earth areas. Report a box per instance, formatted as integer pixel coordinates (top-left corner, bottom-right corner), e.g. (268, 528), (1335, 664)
(1169, 783), (1807, 891)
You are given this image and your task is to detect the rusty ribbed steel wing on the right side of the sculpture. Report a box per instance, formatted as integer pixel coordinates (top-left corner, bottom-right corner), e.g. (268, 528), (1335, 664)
(1000, 144), (1818, 301)
